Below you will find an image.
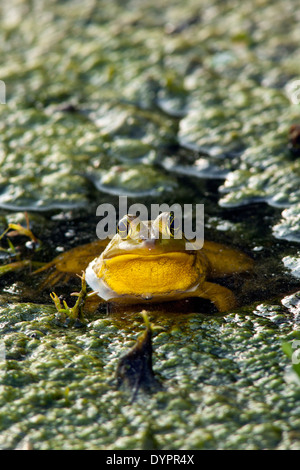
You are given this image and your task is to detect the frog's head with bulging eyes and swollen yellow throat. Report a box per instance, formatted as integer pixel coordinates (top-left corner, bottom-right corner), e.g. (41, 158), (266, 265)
(86, 212), (206, 300)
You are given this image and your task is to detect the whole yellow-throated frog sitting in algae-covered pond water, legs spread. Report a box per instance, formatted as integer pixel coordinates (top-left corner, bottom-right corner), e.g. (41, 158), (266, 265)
(39, 213), (253, 312)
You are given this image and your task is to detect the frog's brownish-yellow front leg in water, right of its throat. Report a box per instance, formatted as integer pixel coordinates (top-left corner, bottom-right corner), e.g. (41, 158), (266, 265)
(193, 282), (237, 312)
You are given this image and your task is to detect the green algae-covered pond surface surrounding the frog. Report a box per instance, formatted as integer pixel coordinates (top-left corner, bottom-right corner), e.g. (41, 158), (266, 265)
(0, 0), (300, 451)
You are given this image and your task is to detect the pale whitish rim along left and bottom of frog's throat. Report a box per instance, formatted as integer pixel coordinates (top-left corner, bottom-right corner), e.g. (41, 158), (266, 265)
(85, 258), (203, 304)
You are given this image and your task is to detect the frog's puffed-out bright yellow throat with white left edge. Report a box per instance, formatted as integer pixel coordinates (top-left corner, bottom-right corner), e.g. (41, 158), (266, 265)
(86, 252), (204, 300)
